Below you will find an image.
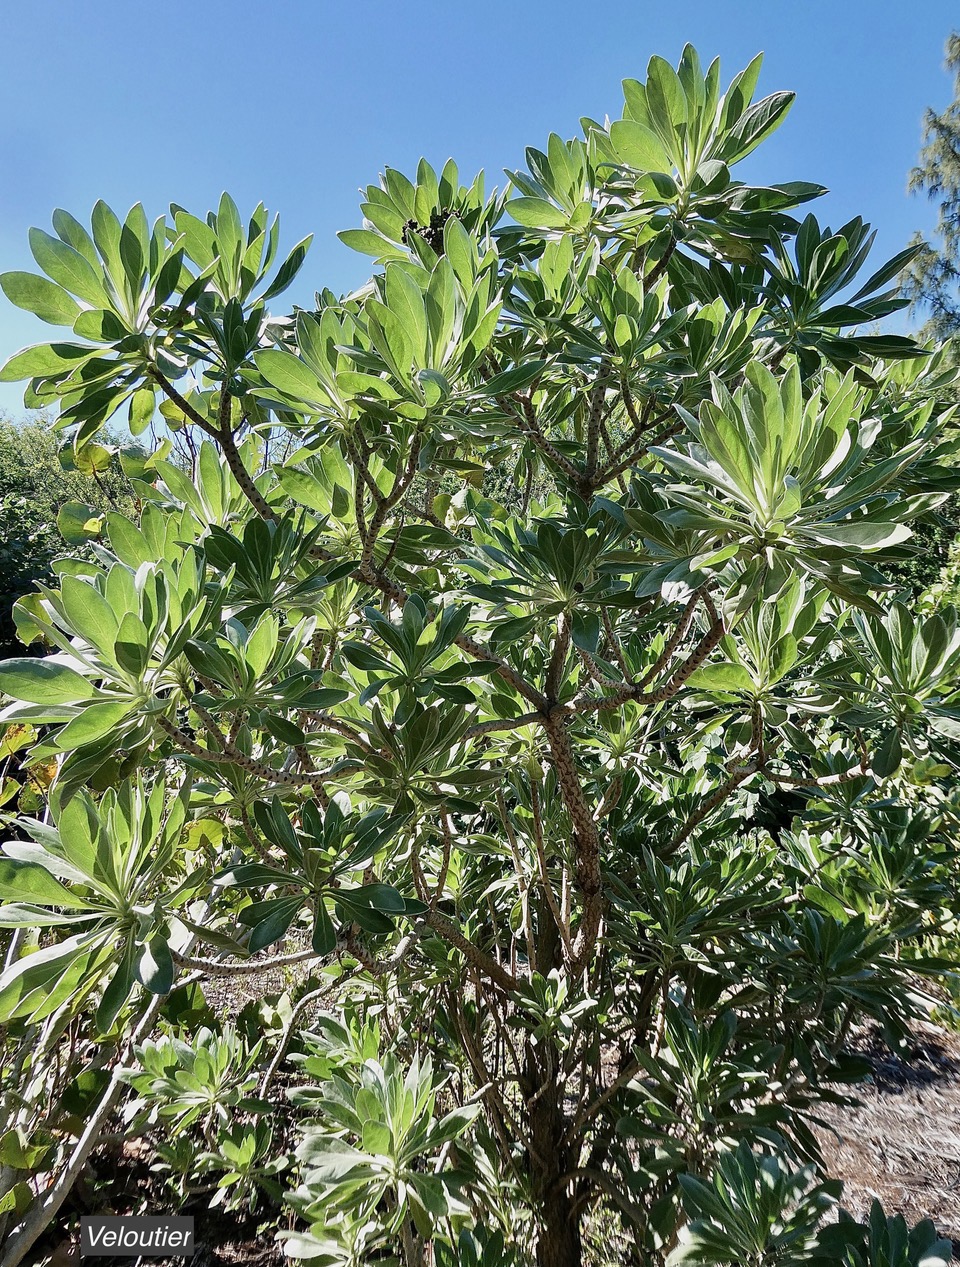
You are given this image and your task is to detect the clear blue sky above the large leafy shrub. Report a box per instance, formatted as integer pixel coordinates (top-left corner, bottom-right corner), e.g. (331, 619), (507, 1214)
(0, 0), (960, 414)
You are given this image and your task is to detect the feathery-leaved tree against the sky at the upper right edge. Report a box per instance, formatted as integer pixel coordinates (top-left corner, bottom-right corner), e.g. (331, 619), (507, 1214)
(904, 33), (960, 338)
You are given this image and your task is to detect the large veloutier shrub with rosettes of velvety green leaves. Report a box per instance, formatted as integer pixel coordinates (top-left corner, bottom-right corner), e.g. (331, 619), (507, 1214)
(0, 48), (960, 1267)
